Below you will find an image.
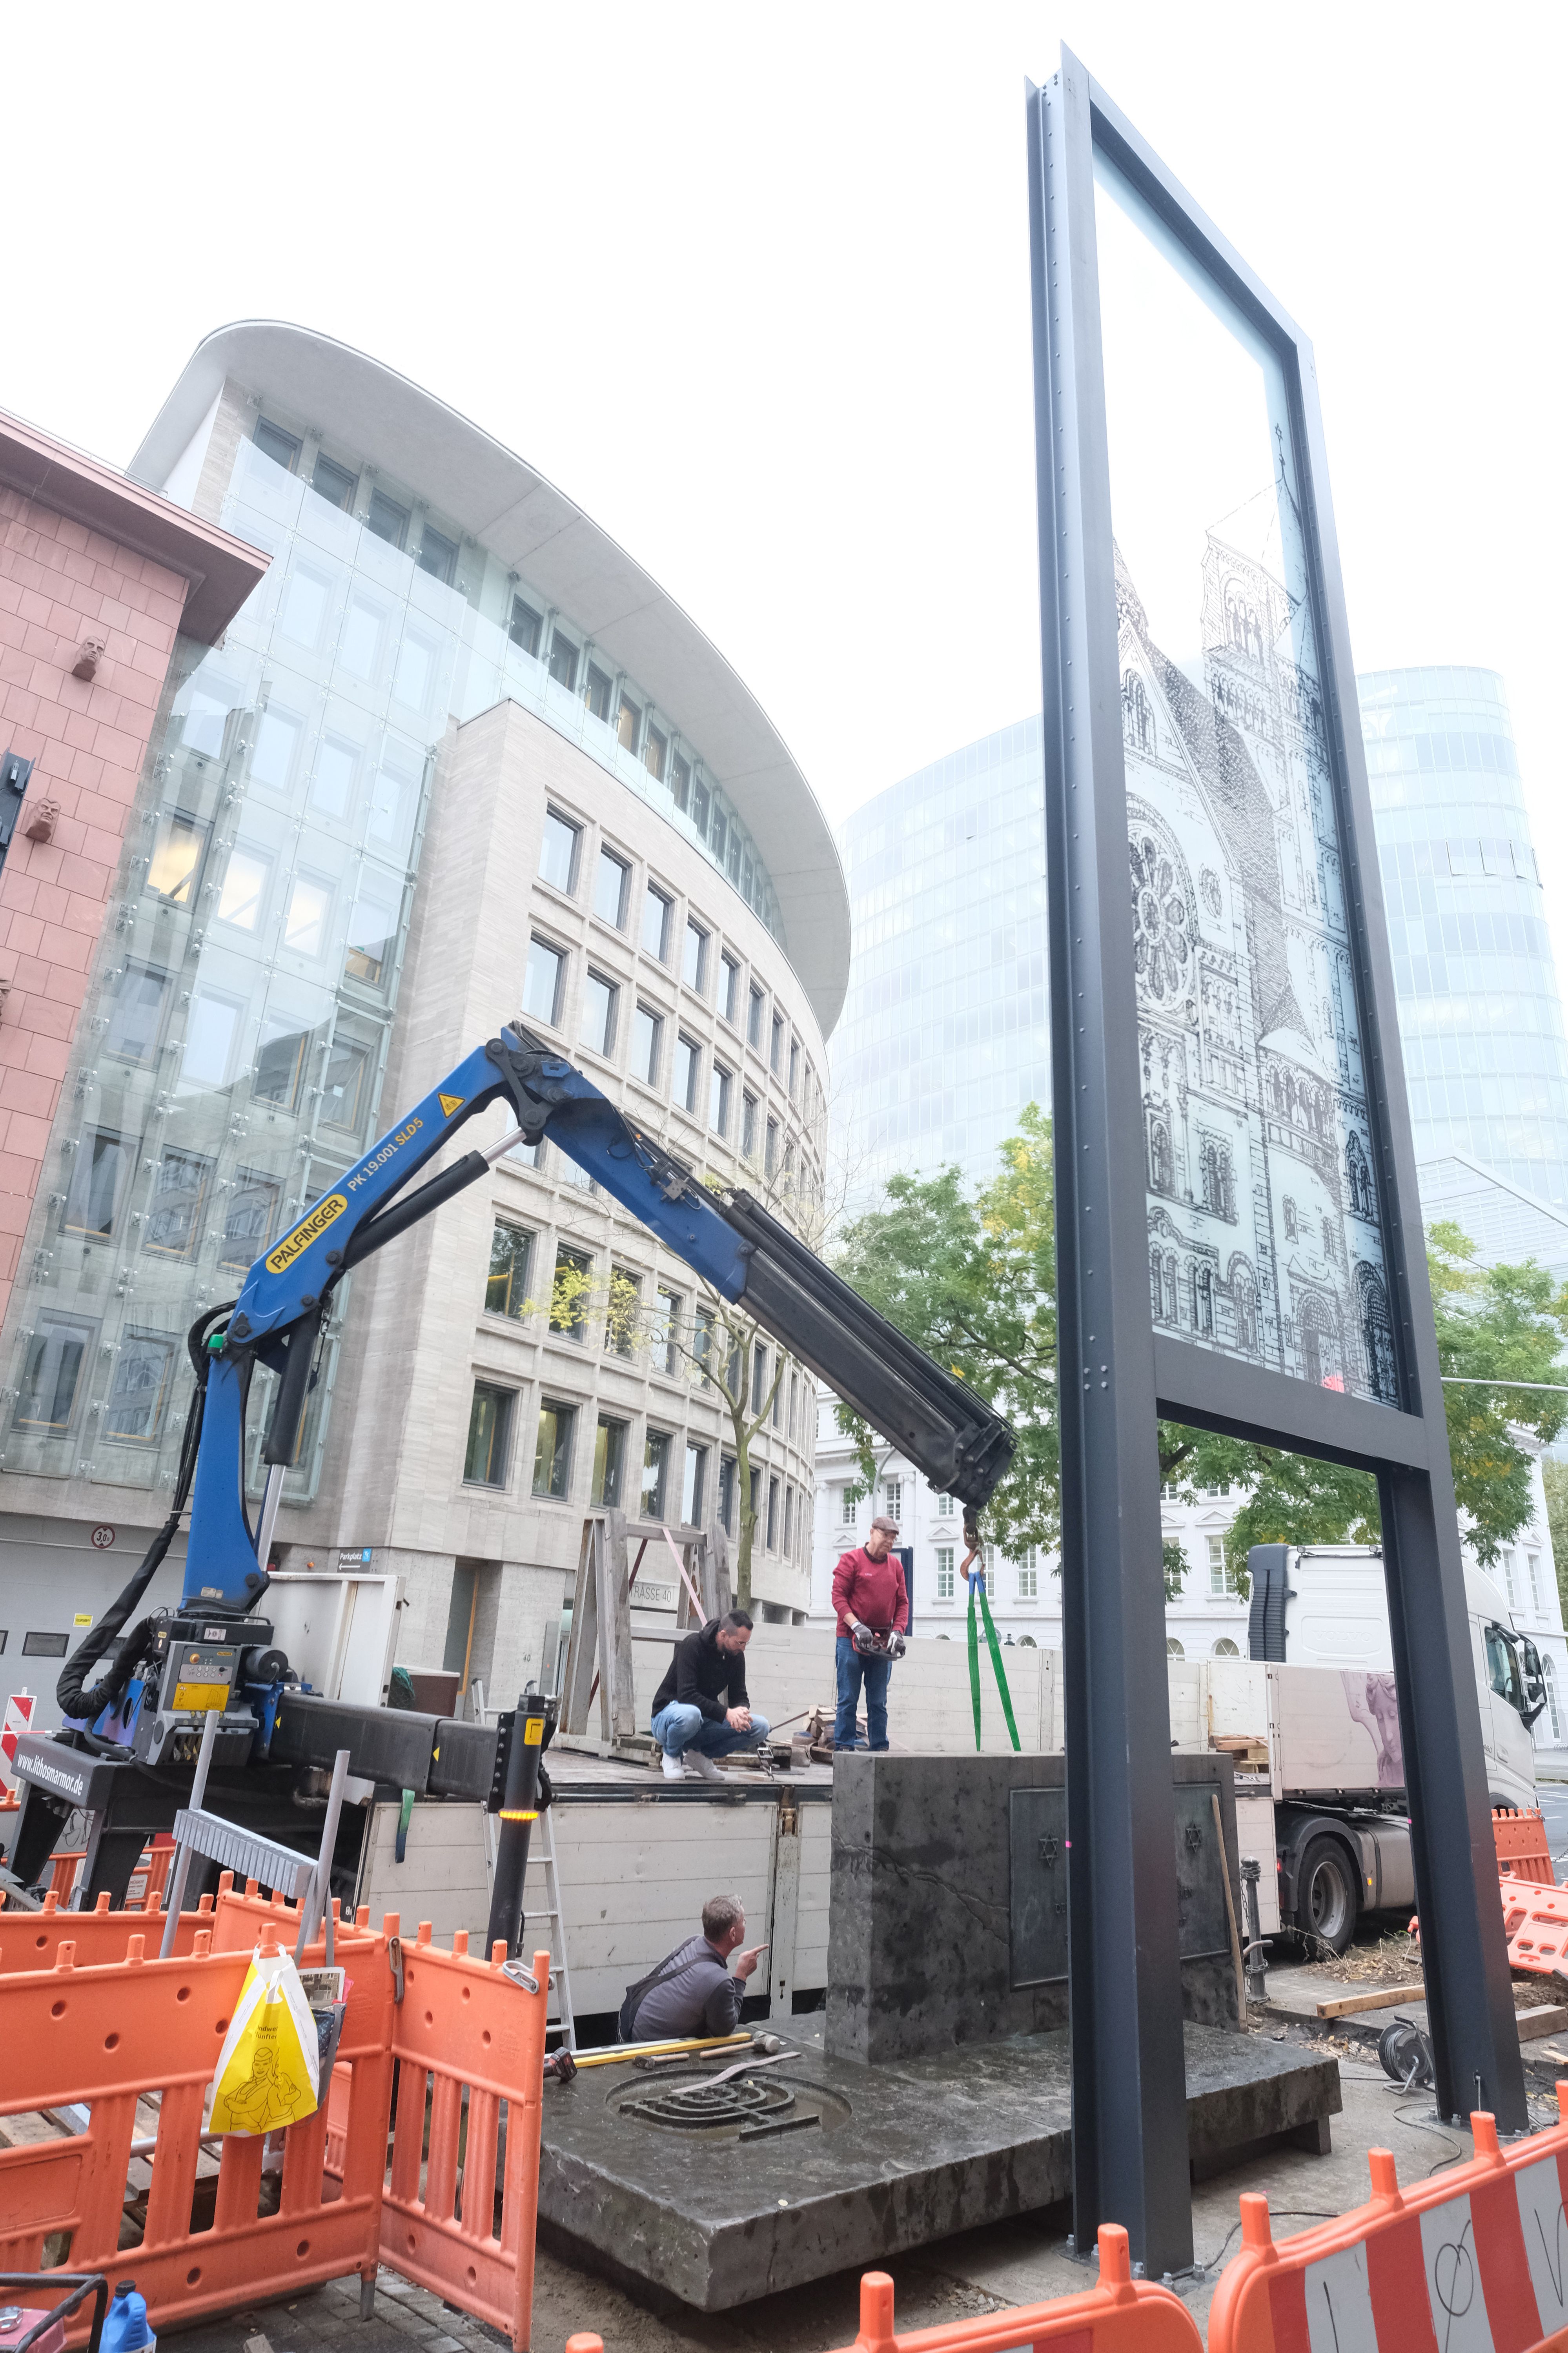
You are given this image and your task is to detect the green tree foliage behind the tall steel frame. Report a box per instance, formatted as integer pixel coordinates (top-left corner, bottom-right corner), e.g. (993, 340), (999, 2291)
(836, 1104), (1568, 1600)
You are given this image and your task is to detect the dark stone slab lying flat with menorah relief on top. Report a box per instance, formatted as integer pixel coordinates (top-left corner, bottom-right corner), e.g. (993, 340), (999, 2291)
(539, 2026), (1340, 2311)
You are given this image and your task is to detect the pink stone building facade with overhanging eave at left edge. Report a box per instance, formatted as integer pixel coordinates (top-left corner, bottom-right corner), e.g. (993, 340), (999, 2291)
(0, 414), (268, 1346)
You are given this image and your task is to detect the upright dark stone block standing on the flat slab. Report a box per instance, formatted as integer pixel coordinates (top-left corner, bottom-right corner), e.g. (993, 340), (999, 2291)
(827, 1751), (1241, 2066)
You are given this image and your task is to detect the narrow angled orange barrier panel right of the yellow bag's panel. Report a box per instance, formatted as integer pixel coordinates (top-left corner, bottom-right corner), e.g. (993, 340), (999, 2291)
(381, 1915), (551, 2353)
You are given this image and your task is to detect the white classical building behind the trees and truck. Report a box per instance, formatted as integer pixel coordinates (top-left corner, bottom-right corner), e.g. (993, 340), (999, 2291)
(810, 1395), (1568, 1748)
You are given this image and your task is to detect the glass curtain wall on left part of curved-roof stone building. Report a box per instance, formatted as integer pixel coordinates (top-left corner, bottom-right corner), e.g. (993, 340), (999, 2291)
(2, 440), (440, 1497)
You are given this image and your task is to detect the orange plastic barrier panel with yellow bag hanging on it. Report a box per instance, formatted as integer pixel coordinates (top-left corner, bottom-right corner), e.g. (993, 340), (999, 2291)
(0, 1913), (393, 2346)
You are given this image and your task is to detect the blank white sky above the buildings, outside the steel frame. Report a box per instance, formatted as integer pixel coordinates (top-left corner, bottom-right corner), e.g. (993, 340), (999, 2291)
(12, 0), (1568, 972)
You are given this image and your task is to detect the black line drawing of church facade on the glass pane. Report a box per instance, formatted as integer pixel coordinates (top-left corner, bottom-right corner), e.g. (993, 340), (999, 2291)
(1116, 532), (1399, 1402)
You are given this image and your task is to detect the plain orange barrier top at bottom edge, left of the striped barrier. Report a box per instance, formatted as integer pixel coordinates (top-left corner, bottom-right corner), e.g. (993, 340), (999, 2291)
(565, 2221), (1191, 2353)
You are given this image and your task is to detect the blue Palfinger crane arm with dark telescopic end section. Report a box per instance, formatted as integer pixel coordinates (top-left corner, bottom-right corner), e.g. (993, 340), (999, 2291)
(184, 1024), (1013, 1612)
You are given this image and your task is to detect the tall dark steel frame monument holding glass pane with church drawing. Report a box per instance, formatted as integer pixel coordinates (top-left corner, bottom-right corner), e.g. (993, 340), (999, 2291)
(1027, 49), (1526, 2273)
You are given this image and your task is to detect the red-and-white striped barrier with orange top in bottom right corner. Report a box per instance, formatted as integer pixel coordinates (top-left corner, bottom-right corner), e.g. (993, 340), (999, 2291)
(1208, 2082), (1568, 2353)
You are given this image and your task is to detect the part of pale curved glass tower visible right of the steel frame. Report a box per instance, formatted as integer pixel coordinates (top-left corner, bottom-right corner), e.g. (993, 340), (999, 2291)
(1356, 668), (1568, 1214)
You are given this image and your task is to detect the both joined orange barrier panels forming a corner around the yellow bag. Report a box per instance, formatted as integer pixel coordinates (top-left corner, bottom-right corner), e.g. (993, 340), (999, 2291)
(0, 1873), (548, 2353)
